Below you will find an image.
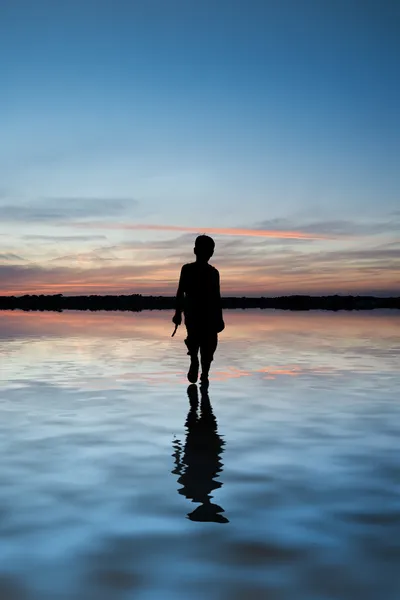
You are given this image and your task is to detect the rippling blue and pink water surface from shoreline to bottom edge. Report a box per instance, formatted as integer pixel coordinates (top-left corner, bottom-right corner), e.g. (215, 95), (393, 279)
(0, 311), (400, 600)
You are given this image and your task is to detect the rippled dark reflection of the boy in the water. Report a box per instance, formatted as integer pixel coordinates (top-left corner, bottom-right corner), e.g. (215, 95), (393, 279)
(173, 385), (228, 523)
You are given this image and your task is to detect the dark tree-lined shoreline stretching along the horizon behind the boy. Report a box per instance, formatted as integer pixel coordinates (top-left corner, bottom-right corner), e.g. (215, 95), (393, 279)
(0, 294), (400, 312)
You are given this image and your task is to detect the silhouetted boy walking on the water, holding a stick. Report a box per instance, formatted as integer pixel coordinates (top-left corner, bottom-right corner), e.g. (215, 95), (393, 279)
(172, 235), (225, 383)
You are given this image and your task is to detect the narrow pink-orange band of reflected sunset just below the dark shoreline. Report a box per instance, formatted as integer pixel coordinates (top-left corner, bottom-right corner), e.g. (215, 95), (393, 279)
(0, 310), (400, 339)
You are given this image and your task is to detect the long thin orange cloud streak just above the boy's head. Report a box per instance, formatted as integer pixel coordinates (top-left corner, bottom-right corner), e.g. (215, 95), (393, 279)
(73, 222), (332, 240)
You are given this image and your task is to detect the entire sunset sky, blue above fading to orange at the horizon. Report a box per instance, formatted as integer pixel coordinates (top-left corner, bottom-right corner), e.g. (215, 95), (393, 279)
(0, 0), (400, 296)
